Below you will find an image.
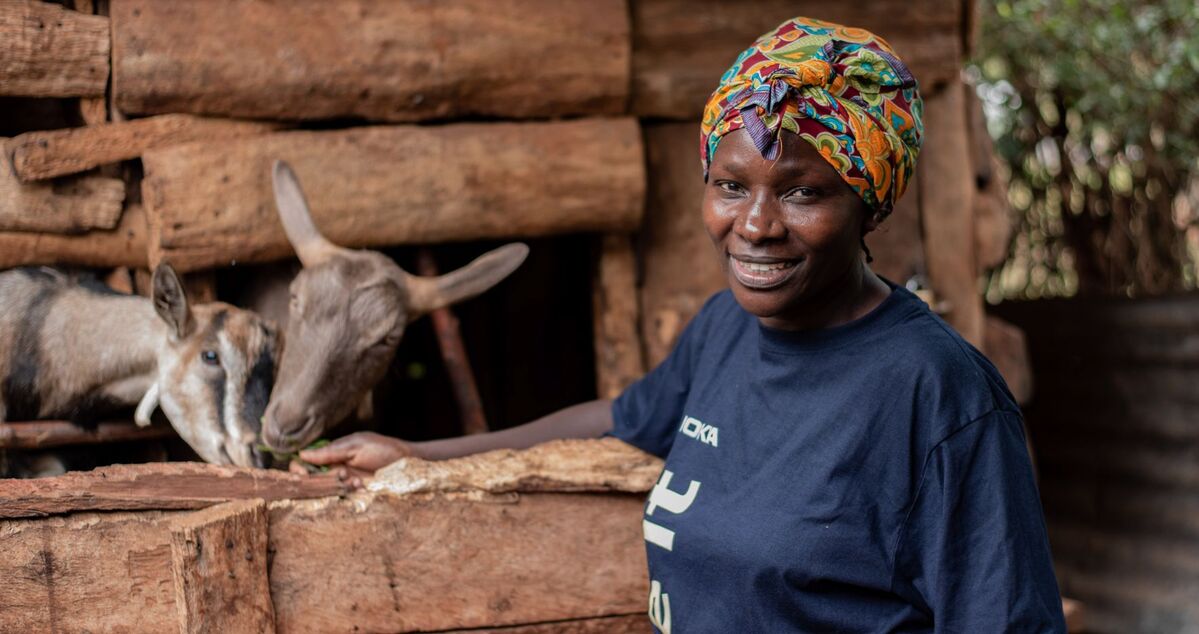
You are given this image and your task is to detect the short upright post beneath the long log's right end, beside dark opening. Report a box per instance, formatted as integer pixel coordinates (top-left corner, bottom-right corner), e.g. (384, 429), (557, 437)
(591, 234), (645, 398)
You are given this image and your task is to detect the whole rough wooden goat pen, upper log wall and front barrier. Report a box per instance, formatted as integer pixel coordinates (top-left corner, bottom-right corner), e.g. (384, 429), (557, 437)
(0, 0), (1064, 632)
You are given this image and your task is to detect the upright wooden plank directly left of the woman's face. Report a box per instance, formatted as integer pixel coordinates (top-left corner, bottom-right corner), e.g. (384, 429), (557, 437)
(639, 121), (728, 368)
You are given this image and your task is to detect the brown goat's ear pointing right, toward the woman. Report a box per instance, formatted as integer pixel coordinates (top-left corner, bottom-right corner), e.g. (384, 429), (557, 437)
(404, 242), (529, 319)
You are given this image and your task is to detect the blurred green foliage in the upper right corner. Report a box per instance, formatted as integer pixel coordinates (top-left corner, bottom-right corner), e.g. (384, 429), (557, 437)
(968, 0), (1199, 300)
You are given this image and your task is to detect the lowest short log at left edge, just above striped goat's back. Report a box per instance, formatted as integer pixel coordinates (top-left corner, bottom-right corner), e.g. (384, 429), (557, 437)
(0, 205), (146, 268)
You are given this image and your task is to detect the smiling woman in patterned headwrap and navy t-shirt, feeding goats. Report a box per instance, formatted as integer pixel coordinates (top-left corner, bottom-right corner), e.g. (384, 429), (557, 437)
(302, 18), (1065, 633)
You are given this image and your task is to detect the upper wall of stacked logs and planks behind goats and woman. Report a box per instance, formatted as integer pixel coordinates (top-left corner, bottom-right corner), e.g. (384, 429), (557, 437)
(0, 0), (1028, 424)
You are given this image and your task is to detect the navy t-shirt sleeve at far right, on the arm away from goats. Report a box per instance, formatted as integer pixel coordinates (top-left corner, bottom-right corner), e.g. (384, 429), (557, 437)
(893, 411), (1066, 633)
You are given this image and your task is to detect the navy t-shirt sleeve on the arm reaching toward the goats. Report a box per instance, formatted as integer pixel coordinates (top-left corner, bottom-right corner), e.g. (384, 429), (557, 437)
(611, 288), (721, 458)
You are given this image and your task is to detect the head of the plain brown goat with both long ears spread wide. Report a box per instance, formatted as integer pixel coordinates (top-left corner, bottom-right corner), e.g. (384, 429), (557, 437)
(263, 162), (529, 452)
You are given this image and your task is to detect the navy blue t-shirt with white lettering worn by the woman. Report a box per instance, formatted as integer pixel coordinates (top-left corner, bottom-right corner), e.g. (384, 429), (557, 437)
(613, 288), (1066, 634)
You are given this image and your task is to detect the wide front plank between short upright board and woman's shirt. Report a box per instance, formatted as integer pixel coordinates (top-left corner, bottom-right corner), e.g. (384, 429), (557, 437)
(270, 494), (649, 633)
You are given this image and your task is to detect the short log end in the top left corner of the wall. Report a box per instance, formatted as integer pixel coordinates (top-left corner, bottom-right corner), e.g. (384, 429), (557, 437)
(0, 0), (109, 97)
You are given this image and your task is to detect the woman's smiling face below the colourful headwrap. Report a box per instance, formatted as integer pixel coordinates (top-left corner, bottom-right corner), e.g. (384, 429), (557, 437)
(704, 129), (876, 330)
